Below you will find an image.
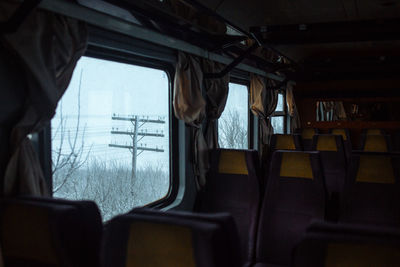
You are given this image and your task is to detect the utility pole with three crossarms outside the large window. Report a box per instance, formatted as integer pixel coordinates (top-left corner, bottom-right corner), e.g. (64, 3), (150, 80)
(108, 114), (165, 185)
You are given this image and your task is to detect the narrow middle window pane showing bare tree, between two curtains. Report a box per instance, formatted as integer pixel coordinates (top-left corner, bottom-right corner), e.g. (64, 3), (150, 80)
(218, 83), (249, 149)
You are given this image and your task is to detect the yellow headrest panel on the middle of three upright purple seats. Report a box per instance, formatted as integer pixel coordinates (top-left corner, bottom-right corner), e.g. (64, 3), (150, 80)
(280, 152), (314, 179)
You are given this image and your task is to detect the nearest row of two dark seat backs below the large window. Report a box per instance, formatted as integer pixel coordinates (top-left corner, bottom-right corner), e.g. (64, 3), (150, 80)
(0, 197), (241, 267)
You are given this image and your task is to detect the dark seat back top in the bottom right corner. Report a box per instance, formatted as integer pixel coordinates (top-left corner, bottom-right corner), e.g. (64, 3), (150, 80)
(292, 223), (400, 267)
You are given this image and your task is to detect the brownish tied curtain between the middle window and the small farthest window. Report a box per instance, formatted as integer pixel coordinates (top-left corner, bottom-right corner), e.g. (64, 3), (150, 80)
(250, 74), (278, 158)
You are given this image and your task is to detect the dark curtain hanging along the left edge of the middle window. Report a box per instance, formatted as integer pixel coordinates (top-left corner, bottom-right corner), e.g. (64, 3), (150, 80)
(203, 60), (229, 149)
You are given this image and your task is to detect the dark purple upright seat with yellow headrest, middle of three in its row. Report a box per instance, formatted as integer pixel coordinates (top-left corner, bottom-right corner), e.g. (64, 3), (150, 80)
(256, 151), (327, 266)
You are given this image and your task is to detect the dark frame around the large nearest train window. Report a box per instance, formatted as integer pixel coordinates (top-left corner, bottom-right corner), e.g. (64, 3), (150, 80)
(38, 40), (180, 209)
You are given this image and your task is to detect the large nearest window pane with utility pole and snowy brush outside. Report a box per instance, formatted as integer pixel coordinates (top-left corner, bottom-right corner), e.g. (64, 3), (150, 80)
(51, 57), (170, 220)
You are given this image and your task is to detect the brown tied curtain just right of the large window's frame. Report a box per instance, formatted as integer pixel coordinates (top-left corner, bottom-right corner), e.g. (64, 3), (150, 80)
(173, 52), (208, 189)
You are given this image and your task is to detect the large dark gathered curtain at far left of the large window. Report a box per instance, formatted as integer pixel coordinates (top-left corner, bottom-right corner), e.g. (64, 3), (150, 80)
(0, 1), (87, 196)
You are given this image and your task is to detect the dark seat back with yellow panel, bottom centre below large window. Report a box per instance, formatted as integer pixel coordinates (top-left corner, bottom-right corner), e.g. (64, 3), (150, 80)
(102, 213), (240, 267)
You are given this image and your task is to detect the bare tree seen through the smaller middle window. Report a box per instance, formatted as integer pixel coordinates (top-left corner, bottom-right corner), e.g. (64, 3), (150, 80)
(218, 110), (248, 149)
